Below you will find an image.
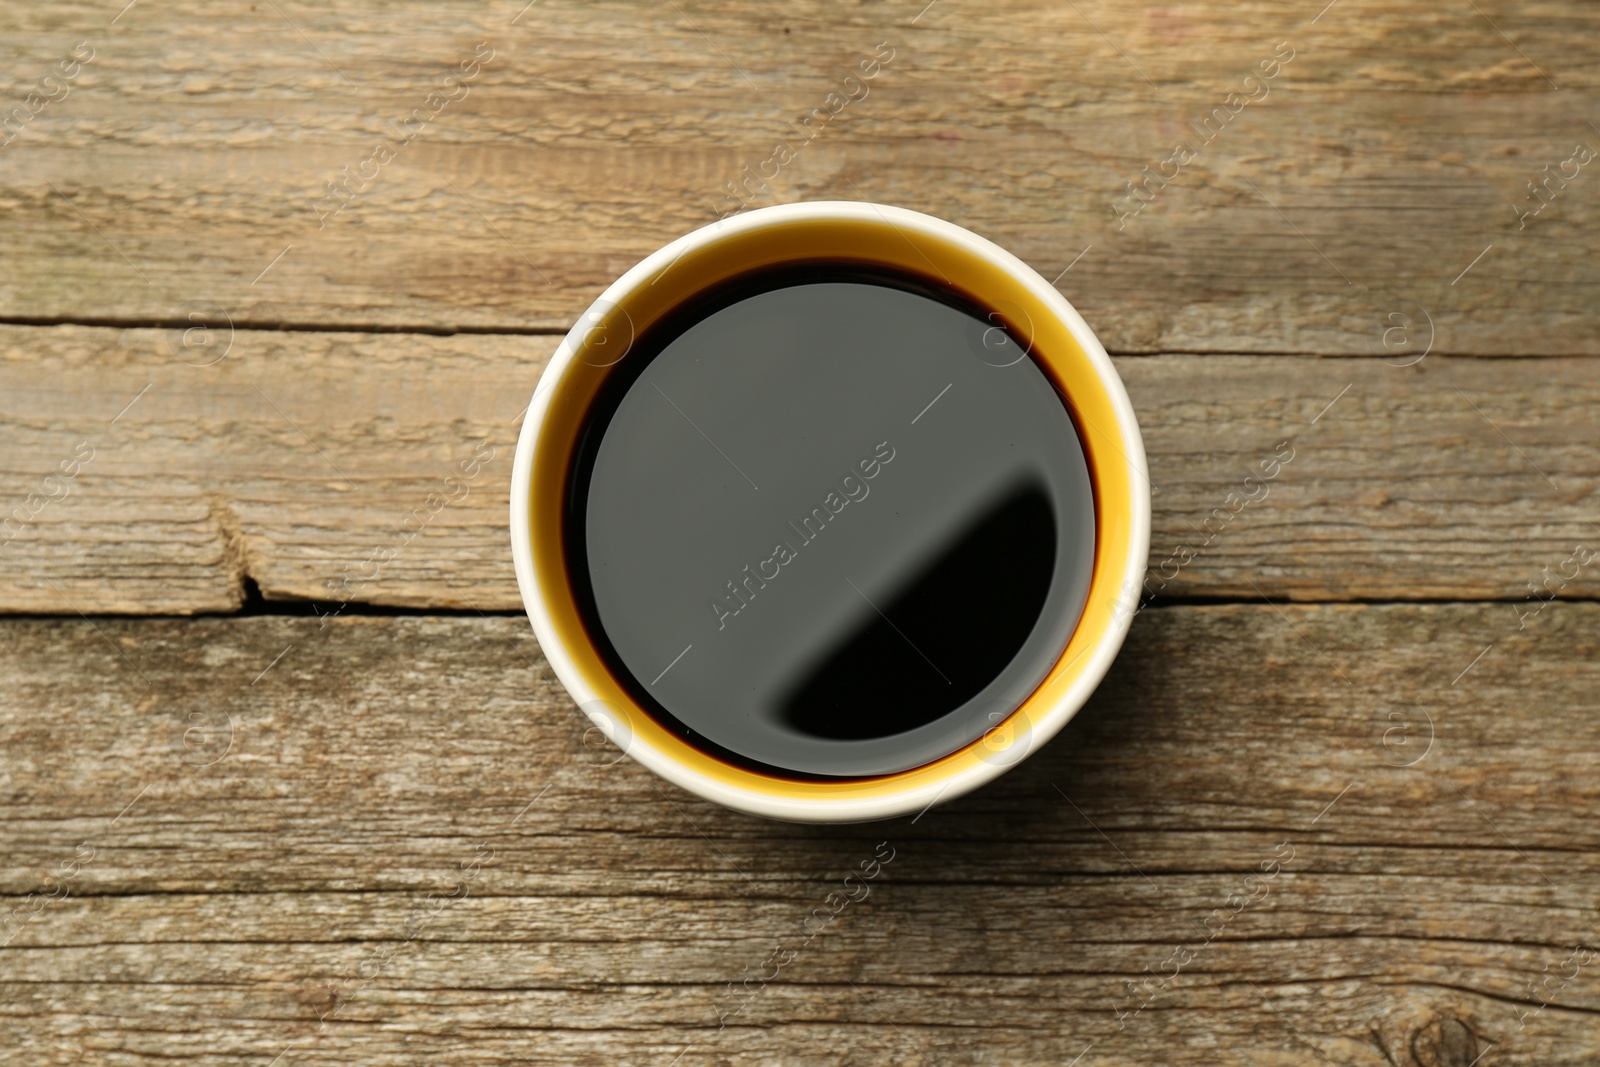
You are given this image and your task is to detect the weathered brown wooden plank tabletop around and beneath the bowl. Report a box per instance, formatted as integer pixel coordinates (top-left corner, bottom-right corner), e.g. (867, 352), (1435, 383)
(0, 0), (1600, 1067)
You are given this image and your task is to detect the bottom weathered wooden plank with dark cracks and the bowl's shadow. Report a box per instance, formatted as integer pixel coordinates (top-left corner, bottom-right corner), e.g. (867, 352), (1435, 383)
(0, 605), (1600, 1067)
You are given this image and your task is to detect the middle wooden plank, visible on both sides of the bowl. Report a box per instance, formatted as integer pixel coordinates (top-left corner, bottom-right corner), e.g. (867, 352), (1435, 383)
(0, 326), (1600, 614)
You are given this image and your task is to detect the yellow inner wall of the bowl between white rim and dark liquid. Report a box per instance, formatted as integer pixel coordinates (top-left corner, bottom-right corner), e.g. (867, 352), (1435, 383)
(528, 219), (1134, 800)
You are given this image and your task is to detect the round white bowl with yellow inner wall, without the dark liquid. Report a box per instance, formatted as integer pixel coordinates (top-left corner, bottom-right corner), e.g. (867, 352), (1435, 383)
(510, 202), (1150, 822)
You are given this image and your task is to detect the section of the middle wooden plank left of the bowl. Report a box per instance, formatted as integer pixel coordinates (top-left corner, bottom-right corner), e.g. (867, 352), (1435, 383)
(0, 326), (540, 613)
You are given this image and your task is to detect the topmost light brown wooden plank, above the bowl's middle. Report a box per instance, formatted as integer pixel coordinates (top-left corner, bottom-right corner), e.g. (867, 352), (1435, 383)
(0, 0), (1600, 355)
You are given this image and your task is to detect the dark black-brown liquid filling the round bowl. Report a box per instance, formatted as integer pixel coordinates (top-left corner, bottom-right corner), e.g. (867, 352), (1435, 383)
(565, 267), (1094, 777)
